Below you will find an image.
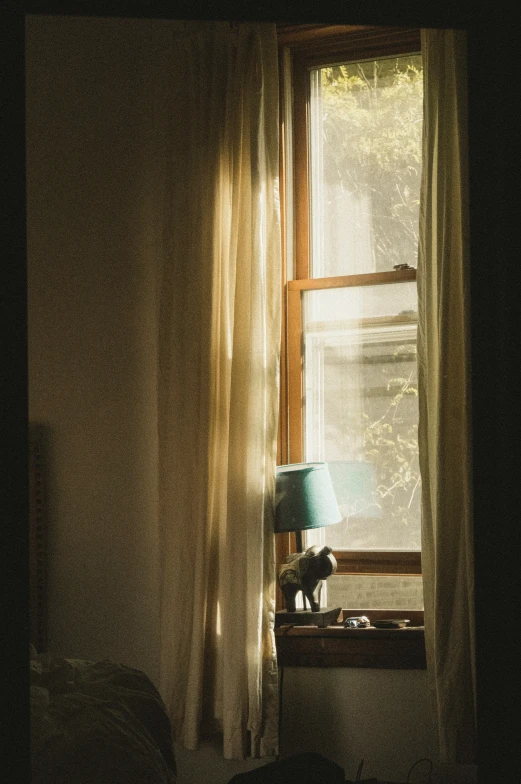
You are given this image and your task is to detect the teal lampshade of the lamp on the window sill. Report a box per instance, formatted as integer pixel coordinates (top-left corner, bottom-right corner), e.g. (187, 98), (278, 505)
(275, 463), (342, 533)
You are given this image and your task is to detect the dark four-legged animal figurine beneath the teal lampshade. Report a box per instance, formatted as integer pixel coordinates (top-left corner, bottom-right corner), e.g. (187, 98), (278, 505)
(279, 544), (337, 612)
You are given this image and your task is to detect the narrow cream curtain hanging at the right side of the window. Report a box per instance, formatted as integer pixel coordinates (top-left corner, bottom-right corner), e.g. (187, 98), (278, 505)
(418, 30), (476, 763)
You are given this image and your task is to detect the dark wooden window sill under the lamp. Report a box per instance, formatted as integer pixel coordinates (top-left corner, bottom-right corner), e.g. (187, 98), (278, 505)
(275, 626), (427, 670)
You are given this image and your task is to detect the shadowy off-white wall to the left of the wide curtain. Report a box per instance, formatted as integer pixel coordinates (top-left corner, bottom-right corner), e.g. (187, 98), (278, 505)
(27, 17), (171, 680)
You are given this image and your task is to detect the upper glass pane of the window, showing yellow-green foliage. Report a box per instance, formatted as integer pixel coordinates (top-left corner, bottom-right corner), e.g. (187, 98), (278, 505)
(310, 55), (423, 278)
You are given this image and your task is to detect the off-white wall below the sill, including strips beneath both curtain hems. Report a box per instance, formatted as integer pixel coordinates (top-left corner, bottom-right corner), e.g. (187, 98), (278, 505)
(172, 667), (476, 784)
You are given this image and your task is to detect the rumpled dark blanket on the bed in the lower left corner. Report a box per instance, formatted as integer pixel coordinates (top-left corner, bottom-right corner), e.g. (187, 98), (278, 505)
(30, 654), (176, 784)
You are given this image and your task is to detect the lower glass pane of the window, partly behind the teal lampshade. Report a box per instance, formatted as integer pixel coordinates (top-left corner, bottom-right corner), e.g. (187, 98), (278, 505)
(302, 282), (421, 551)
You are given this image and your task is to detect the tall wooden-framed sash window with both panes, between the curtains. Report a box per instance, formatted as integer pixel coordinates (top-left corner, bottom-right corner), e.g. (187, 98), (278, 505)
(279, 23), (423, 610)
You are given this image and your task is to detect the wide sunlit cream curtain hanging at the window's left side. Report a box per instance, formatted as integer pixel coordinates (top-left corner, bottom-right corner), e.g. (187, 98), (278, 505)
(158, 22), (280, 758)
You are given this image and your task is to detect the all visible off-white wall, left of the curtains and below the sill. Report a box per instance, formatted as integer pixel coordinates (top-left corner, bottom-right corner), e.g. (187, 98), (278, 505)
(27, 17), (476, 784)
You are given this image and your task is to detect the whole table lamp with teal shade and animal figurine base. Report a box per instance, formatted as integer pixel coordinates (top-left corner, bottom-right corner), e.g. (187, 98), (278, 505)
(275, 463), (342, 626)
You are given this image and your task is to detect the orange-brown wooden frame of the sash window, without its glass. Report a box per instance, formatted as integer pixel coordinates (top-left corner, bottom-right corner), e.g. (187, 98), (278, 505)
(276, 24), (423, 618)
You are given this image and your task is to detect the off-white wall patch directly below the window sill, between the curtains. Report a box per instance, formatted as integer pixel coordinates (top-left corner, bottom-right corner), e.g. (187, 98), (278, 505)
(282, 667), (436, 781)
